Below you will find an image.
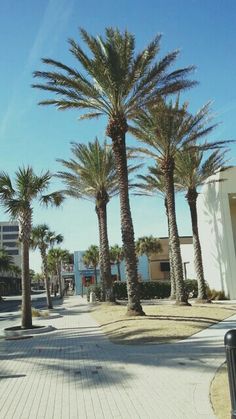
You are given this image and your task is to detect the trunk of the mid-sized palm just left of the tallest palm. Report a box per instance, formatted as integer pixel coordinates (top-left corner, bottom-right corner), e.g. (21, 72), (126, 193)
(96, 202), (114, 301)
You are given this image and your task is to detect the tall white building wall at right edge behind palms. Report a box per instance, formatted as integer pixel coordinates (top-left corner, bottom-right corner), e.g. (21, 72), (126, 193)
(198, 167), (236, 299)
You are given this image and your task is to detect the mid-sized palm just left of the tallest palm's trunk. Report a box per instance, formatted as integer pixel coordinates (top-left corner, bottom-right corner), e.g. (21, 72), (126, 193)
(58, 138), (119, 299)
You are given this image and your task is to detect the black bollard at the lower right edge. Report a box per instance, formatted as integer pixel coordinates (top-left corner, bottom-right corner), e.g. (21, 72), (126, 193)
(224, 329), (236, 419)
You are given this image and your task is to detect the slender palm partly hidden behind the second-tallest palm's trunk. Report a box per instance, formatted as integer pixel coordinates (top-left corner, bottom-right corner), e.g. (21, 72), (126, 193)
(135, 164), (176, 300)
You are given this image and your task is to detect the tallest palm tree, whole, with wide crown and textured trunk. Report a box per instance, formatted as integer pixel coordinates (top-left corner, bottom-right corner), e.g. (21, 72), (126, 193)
(33, 28), (195, 315)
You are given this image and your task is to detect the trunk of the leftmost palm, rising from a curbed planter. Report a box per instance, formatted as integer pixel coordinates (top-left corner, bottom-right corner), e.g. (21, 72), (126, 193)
(21, 238), (32, 329)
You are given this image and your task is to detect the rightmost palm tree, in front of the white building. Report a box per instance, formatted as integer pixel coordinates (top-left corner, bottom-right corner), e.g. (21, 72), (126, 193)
(176, 149), (226, 302)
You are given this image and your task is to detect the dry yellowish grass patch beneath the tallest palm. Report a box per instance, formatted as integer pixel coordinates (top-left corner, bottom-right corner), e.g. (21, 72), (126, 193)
(91, 303), (236, 344)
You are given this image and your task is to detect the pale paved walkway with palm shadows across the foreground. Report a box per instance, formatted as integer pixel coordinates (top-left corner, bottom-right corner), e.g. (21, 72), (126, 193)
(0, 296), (232, 419)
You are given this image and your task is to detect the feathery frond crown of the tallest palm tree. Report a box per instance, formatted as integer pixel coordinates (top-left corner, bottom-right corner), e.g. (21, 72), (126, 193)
(33, 28), (195, 119)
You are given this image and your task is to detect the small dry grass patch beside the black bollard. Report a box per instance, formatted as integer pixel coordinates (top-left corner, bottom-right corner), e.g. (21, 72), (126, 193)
(210, 363), (231, 419)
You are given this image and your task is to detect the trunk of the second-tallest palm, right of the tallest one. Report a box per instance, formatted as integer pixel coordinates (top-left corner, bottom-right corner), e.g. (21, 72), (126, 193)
(162, 158), (189, 305)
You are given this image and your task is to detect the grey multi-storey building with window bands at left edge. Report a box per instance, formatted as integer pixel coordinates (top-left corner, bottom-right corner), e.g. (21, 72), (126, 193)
(0, 221), (21, 267)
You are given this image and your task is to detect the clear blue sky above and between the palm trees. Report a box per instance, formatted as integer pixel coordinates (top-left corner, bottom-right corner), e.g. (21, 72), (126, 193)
(0, 0), (236, 270)
